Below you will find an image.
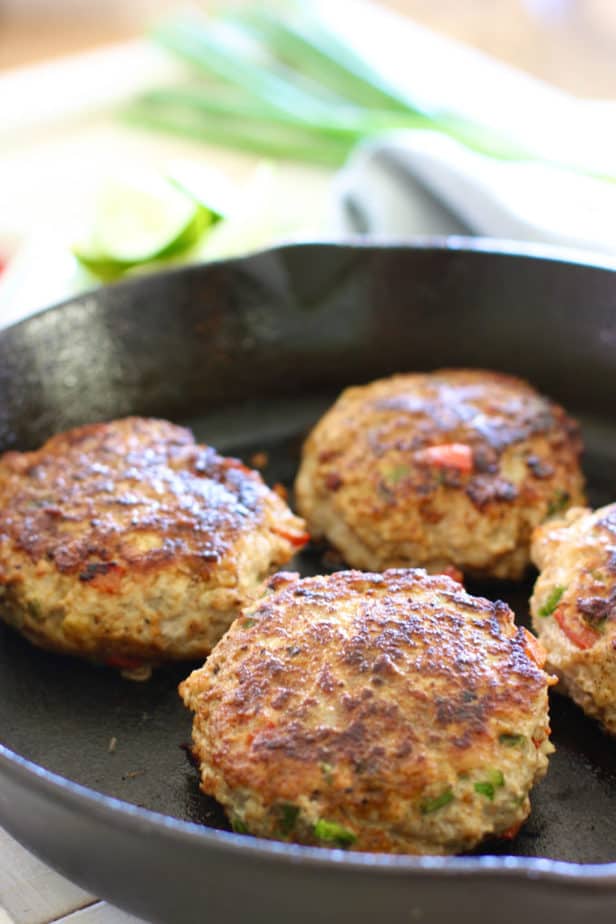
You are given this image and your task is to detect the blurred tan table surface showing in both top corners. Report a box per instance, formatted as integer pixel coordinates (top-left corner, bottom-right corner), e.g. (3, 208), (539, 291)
(0, 0), (616, 97)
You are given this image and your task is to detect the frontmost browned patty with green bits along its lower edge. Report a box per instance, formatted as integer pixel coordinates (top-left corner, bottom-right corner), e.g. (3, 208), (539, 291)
(180, 570), (552, 854)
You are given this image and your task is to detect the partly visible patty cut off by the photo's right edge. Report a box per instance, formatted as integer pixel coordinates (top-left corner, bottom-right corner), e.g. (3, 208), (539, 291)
(531, 504), (616, 734)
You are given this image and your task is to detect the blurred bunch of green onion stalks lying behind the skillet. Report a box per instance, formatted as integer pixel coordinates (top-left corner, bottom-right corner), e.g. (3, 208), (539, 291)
(123, 2), (606, 179)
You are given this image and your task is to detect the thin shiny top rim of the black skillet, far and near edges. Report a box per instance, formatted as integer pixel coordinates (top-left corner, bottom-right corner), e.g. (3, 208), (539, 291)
(0, 236), (616, 889)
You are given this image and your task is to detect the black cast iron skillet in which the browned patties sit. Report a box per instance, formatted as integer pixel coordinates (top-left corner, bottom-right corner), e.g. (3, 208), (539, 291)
(0, 239), (616, 924)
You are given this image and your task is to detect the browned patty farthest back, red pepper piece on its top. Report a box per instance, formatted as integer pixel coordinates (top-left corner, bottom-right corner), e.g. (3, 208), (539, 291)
(295, 369), (585, 579)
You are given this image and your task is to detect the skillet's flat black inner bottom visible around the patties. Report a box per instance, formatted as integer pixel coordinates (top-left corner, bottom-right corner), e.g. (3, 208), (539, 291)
(0, 395), (616, 863)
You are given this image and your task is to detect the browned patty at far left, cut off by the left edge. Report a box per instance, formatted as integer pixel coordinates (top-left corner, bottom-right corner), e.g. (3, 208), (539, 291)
(0, 417), (307, 667)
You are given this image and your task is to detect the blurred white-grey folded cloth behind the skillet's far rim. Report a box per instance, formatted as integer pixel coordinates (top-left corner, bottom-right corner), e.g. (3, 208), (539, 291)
(334, 126), (616, 254)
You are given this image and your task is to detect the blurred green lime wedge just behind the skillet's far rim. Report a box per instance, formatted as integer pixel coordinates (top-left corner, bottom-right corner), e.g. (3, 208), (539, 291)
(73, 174), (218, 280)
